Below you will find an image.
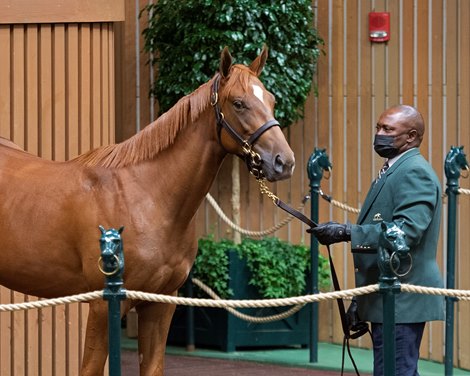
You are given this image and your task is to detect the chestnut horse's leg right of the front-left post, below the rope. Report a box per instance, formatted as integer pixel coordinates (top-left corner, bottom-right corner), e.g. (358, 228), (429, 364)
(136, 292), (176, 376)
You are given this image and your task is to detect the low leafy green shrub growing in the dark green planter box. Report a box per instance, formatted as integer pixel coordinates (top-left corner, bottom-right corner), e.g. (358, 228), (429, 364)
(193, 235), (330, 298)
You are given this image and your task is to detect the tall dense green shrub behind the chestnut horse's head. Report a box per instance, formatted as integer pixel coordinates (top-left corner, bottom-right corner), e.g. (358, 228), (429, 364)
(143, 0), (322, 126)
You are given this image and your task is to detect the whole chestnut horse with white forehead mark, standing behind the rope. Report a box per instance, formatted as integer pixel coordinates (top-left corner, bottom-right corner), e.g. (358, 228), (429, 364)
(0, 48), (294, 376)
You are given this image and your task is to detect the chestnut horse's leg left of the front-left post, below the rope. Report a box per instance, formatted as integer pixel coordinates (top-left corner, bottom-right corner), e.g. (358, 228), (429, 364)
(81, 300), (108, 376)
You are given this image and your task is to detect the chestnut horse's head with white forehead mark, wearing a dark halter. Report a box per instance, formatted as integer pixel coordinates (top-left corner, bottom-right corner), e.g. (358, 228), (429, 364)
(211, 48), (295, 181)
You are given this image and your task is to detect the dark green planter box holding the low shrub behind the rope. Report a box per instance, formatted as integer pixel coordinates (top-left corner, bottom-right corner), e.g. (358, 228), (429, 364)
(168, 251), (310, 352)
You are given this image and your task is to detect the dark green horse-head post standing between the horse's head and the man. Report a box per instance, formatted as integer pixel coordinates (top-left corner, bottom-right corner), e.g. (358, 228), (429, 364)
(307, 148), (331, 363)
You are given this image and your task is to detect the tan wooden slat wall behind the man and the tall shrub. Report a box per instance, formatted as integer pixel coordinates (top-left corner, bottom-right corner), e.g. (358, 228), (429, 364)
(116, 0), (470, 369)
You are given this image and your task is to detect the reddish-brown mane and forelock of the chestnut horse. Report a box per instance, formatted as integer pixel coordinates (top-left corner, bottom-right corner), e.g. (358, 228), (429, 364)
(72, 65), (253, 168)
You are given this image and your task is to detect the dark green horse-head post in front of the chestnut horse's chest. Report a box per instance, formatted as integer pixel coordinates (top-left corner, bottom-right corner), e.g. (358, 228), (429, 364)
(99, 226), (126, 376)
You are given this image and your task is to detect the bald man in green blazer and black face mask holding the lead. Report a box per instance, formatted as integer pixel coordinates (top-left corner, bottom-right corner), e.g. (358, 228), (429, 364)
(309, 105), (444, 376)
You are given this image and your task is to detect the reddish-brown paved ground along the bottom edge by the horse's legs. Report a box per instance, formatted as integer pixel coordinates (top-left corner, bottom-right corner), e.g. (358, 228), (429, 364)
(121, 350), (360, 376)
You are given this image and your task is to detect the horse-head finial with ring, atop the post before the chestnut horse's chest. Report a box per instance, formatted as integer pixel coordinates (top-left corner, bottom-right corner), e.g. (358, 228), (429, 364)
(98, 225), (124, 276)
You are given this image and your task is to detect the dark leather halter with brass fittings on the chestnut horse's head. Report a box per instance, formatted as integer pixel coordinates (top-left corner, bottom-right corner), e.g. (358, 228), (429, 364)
(211, 74), (280, 179)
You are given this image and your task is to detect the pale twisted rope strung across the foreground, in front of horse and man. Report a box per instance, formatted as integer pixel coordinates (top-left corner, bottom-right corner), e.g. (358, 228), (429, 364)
(0, 283), (470, 312)
